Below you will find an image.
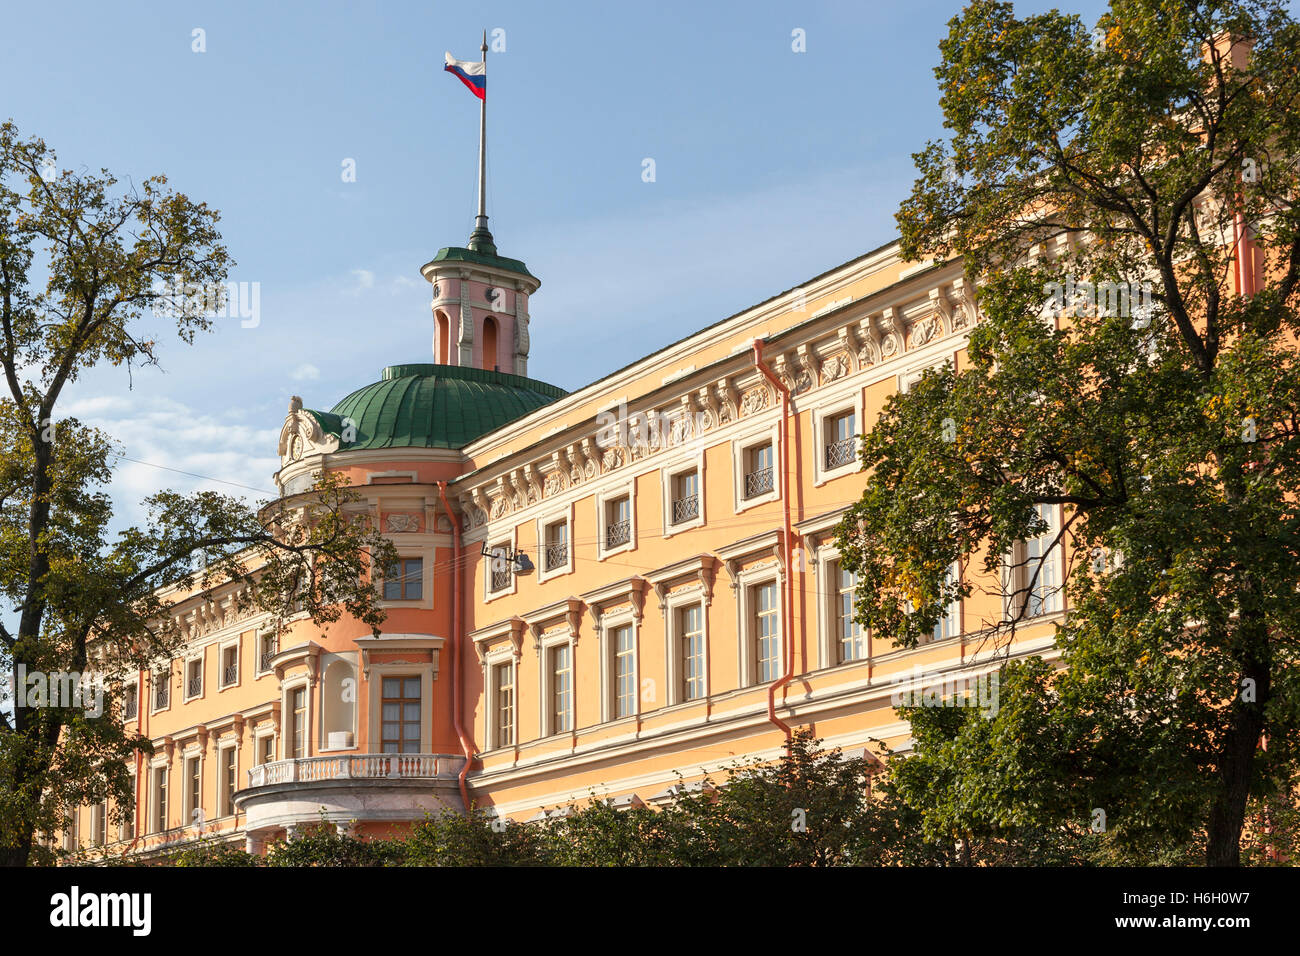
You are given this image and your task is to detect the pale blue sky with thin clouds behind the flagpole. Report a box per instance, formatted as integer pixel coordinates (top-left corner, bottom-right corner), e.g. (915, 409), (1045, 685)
(0, 0), (1118, 520)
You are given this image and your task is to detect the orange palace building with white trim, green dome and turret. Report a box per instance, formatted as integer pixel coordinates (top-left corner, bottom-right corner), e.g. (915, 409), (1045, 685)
(61, 214), (1081, 858)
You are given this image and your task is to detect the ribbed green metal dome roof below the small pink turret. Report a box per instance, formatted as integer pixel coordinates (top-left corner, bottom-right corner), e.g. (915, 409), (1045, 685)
(307, 365), (567, 451)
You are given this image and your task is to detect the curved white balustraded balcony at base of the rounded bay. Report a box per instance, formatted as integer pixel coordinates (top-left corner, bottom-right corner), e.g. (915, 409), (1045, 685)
(235, 753), (465, 840)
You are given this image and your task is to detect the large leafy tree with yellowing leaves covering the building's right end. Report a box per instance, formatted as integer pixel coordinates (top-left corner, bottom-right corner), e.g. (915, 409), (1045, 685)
(839, 0), (1300, 865)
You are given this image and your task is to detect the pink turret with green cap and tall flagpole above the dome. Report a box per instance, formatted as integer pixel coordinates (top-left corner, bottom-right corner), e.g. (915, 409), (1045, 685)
(420, 31), (542, 376)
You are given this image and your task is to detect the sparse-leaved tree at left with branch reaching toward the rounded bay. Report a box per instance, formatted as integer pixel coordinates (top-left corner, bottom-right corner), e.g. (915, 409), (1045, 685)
(0, 122), (391, 865)
